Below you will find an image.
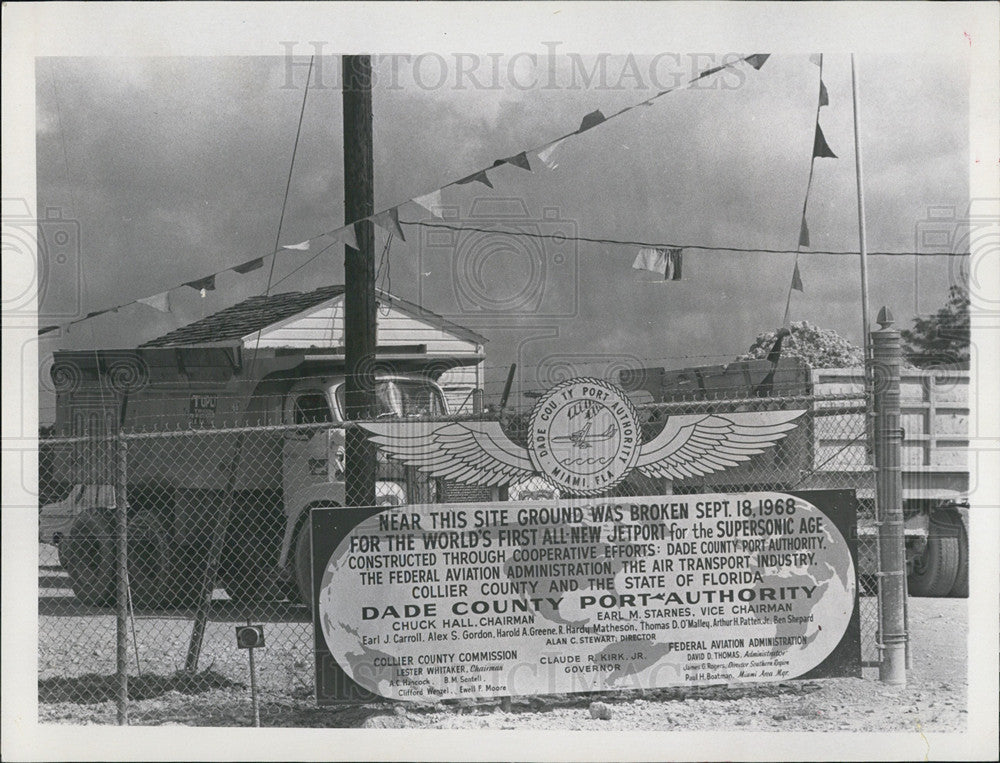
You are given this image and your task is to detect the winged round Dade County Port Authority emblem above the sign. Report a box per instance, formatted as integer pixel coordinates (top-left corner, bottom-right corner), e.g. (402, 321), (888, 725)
(358, 377), (805, 495)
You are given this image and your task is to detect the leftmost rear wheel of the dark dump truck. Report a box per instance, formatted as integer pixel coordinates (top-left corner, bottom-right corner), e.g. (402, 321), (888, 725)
(59, 510), (115, 607)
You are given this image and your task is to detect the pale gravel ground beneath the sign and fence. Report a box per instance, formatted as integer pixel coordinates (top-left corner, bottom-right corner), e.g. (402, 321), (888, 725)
(38, 546), (968, 732)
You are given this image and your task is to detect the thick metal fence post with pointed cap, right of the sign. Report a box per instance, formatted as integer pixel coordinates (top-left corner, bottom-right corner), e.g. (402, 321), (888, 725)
(871, 307), (907, 686)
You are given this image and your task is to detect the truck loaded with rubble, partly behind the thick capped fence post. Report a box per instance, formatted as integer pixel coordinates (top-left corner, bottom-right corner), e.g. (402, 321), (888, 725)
(620, 358), (969, 597)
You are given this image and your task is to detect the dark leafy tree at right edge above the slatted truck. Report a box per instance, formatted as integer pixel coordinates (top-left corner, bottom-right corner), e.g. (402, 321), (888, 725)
(900, 286), (969, 370)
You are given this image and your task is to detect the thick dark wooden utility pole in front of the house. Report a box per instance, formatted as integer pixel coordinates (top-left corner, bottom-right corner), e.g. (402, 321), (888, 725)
(341, 56), (377, 506)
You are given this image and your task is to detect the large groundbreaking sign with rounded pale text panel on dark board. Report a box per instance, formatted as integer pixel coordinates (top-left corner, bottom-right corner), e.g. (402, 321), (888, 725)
(312, 491), (860, 702)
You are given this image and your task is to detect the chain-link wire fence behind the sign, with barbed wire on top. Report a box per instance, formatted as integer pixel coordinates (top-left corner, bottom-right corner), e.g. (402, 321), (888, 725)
(39, 382), (878, 724)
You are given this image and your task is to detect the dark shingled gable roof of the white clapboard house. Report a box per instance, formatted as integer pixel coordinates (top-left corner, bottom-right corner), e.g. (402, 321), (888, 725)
(139, 284), (486, 347)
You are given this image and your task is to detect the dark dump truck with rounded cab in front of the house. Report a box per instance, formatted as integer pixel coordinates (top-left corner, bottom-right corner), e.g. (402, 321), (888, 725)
(39, 346), (475, 607)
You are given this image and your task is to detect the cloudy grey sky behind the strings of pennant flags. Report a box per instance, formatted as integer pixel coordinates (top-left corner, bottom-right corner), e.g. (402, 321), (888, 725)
(36, 42), (976, 412)
